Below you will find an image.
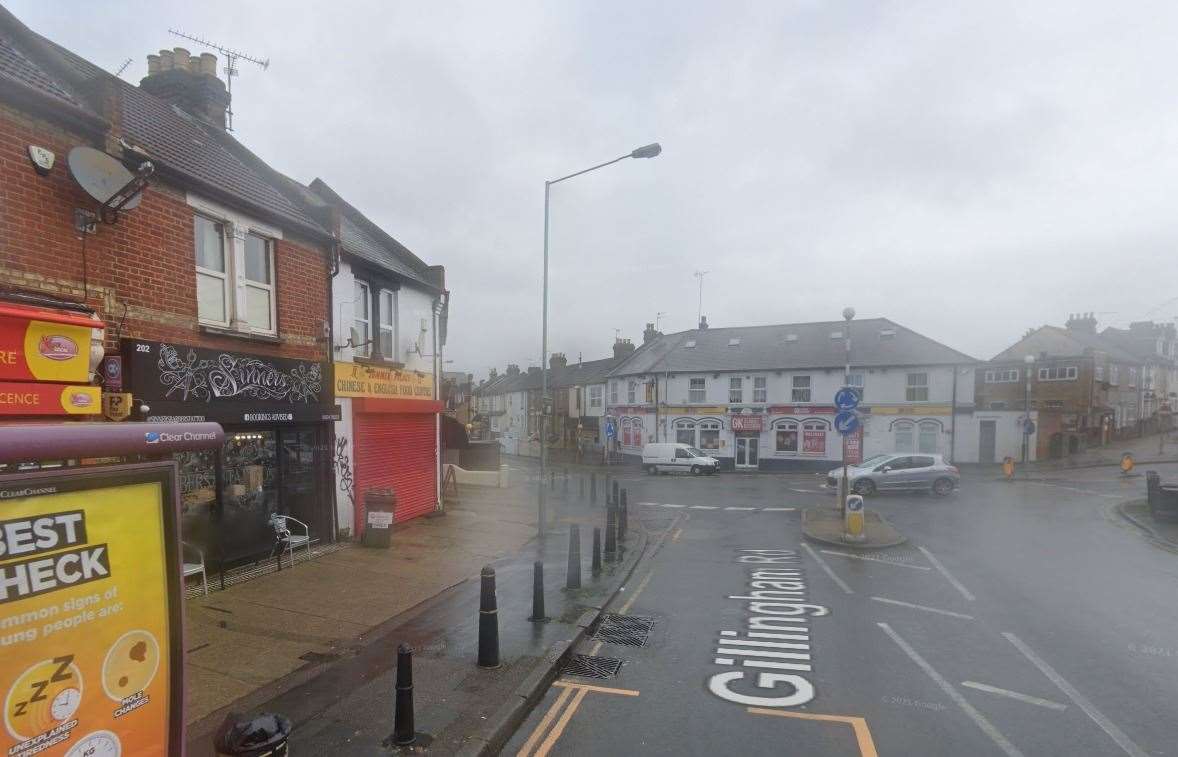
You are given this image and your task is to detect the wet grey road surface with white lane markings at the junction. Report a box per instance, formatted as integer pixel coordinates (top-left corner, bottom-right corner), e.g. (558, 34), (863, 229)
(504, 466), (1178, 756)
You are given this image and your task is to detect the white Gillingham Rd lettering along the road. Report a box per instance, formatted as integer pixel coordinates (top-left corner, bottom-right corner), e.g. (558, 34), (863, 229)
(708, 550), (830, 708)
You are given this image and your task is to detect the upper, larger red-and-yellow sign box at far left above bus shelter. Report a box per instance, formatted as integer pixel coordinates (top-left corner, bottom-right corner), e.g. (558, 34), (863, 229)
(0, 304), (102, 384)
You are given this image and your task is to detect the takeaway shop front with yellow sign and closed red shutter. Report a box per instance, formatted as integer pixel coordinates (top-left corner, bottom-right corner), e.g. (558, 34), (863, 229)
(335, 363), (442, 537)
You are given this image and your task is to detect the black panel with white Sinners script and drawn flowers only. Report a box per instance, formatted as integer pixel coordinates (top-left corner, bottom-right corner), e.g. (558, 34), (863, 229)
(128, 341), (324, 404)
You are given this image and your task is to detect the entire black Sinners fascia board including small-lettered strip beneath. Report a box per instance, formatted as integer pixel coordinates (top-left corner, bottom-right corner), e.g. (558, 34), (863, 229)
(123, 339), (339, 424)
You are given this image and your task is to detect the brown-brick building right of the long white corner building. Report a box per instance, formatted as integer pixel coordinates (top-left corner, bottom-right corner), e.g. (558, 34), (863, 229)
(974, 313), (1144, 458)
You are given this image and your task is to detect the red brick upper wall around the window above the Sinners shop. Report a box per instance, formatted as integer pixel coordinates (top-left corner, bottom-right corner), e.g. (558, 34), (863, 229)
(0, 104), (330, 360)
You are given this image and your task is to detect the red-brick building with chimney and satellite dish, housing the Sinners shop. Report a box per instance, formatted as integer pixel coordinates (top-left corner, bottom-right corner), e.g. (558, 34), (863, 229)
(0, 7), (338, 569)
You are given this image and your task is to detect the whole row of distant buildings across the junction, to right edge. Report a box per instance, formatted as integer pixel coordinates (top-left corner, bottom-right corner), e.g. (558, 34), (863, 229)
(475, 316), (1178, 470)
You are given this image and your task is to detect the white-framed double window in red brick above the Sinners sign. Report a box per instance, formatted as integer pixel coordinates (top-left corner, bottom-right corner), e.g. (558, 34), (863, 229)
(185, 194), (283, 337)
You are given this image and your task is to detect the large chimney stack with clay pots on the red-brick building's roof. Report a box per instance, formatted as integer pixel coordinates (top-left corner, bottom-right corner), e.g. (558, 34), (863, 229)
(139, 47), (229, 128)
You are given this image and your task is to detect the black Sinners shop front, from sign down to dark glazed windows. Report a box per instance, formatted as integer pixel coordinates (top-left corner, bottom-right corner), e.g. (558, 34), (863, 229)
(121, 339), (339, 565)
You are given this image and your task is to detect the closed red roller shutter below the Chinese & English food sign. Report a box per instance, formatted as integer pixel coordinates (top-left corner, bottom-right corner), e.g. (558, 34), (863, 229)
(352, 413), (437, 533)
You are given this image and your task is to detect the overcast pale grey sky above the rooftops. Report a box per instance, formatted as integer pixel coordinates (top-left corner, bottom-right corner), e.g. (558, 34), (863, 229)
(16, 0), (1178, 374)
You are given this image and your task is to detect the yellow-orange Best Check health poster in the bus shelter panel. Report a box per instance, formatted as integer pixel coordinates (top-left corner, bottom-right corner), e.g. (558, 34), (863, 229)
(0, 463), (184, 757)
